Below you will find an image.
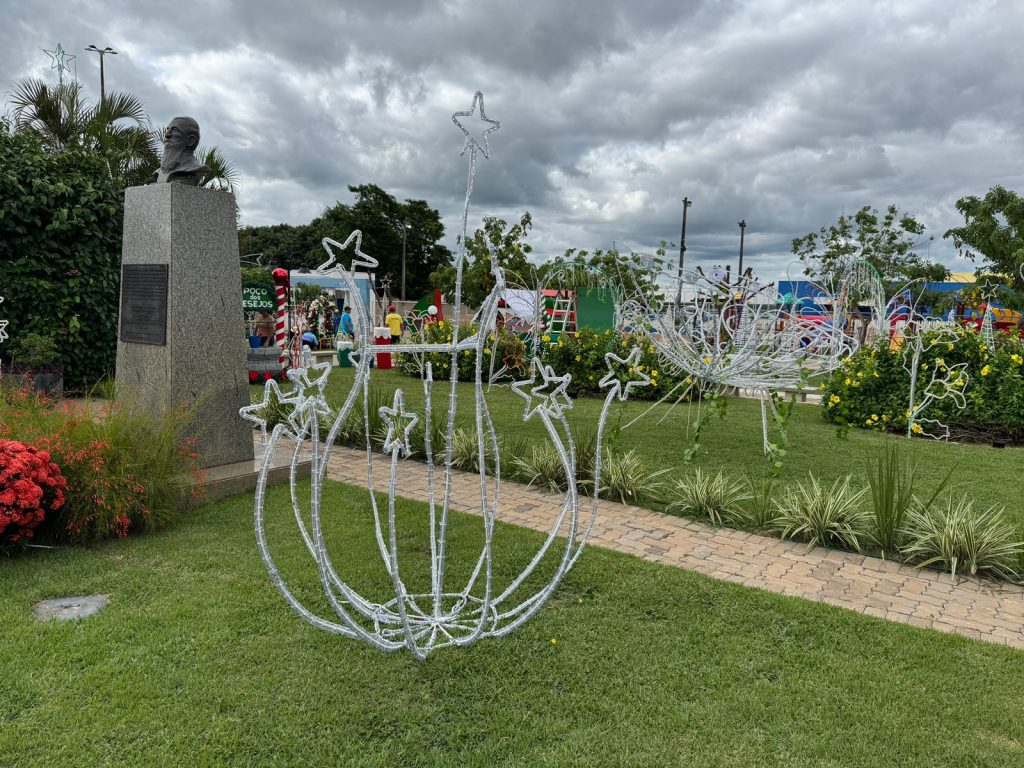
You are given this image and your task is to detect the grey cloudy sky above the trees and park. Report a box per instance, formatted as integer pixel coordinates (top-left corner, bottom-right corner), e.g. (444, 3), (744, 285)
(0, 0), (1024, 279)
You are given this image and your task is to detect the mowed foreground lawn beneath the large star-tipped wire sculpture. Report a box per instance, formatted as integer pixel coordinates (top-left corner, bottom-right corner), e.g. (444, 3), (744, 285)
(6, 481), (1024, 768)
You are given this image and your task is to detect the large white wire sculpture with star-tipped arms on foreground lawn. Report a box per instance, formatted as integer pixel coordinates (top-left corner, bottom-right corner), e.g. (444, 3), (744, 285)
(241, 92), (645, 659)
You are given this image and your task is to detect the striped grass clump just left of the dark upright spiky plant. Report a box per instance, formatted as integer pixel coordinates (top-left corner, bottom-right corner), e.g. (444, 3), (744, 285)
(772, 475), (868, 552)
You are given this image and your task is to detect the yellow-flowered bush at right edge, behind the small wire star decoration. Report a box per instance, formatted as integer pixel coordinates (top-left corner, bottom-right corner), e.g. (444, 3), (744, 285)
(821, 328), (1024, 439)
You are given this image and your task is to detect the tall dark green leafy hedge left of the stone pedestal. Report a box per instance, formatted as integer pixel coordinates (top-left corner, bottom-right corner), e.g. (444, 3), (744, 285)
(0, 128), (124, 389)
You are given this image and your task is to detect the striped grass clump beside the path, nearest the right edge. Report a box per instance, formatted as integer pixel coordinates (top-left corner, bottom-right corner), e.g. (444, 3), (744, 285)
(903, 498), (1024, 580)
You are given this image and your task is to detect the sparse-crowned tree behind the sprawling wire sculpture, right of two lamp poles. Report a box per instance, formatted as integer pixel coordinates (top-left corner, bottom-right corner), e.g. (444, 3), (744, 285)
(793, 205), (949, 283)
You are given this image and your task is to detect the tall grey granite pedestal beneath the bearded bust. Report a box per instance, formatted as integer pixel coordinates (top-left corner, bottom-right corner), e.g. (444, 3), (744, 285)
(117, 184), (253, 467)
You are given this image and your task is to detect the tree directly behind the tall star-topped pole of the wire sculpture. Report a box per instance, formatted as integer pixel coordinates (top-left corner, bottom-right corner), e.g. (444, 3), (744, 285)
(430, 211), (538, 307)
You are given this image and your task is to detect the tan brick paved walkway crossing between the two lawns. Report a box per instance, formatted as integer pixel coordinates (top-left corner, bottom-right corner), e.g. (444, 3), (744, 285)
(313, 446), (1024, 648)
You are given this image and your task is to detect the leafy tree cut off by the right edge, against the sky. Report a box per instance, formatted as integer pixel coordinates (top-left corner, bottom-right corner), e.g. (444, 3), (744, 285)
(943, 186), (1024, 306)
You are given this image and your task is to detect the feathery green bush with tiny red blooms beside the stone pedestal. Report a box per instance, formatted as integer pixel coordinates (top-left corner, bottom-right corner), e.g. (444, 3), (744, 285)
(0, 388), (203, 543)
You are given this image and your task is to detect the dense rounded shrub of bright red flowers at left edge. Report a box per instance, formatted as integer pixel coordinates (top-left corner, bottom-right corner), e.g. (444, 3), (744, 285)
(0, 440), (67, 549)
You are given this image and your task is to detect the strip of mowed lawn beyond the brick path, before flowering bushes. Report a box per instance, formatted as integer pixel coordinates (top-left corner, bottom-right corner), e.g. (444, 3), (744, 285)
(262, 369), (1024, 526)
